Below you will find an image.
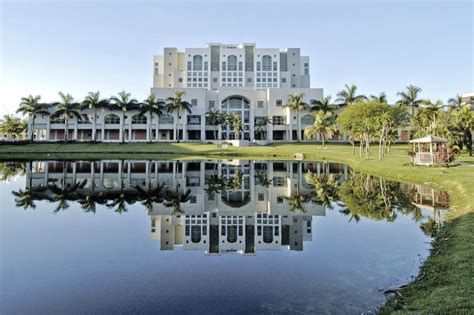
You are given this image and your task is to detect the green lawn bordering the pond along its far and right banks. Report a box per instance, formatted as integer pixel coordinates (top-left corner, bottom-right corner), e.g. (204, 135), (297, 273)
(0, 143), (474, 313)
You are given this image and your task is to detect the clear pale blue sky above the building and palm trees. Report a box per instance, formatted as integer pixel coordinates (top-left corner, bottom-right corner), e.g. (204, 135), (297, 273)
(0, 0), (474, 116)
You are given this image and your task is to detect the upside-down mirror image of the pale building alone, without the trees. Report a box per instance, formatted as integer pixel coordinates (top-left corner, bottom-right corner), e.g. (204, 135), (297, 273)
(26, 160), (348, 255)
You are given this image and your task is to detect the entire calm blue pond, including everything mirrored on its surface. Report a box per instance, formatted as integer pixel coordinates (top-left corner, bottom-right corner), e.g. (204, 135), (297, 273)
(0, 160), (448, 314)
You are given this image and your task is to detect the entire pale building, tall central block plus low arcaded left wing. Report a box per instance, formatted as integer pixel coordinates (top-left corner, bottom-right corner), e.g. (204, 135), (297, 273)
(29, 43), (326, 143)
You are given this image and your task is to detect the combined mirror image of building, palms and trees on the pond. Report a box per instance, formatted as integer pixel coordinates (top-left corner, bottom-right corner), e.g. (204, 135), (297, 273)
(1, 160), (449, 255)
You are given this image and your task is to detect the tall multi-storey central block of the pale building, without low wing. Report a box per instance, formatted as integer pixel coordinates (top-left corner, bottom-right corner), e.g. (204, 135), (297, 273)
(151, 43), (323, 141)
